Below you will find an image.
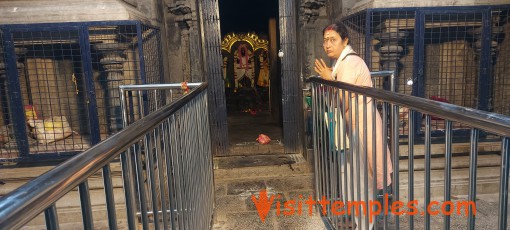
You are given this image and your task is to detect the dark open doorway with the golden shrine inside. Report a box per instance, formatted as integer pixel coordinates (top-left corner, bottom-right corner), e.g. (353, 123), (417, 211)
(219, 0), (283, 155)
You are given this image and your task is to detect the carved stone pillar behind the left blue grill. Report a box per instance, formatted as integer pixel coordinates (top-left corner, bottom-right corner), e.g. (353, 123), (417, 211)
(94, 43), (128, 133)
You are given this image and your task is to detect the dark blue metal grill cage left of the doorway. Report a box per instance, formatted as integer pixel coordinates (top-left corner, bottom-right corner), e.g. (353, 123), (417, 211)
(0, 21), (162, 161)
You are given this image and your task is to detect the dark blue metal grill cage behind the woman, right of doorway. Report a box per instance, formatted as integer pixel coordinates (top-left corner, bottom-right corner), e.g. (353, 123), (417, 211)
(342, 5), (510, 135)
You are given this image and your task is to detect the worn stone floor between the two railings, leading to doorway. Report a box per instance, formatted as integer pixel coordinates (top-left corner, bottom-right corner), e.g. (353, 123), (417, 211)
(213, 154), (325, 230)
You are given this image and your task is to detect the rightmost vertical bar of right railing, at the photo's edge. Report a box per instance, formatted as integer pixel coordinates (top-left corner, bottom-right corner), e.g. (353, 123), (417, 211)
(498, 137), (510, 230)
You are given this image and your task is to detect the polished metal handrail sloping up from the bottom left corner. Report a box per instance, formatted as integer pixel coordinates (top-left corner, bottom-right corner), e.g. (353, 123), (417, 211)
(0, 83), (207, 229)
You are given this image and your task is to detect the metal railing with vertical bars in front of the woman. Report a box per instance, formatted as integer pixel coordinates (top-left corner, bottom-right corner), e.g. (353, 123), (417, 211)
(307, 76), (510, 229)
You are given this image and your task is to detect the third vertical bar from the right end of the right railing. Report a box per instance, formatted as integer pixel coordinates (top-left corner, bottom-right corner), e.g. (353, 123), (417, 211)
(444, 120), (453, 230)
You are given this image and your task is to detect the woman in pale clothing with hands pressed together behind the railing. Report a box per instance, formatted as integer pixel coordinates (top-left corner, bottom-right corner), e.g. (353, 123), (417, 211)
(315, 23), (393, 229)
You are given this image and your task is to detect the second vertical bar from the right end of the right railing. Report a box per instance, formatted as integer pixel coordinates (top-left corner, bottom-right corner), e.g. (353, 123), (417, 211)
(468, 128), (479, 229)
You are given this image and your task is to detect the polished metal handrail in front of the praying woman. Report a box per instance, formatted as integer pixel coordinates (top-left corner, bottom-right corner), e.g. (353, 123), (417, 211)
(306, 76), (510, 137)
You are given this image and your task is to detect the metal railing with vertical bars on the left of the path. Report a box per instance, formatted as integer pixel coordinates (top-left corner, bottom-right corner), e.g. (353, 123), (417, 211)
(0, 83), (214, 229)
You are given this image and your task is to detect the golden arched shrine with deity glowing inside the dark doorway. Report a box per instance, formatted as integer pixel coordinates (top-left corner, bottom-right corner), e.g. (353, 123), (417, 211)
(221, 33), (271, 115)
